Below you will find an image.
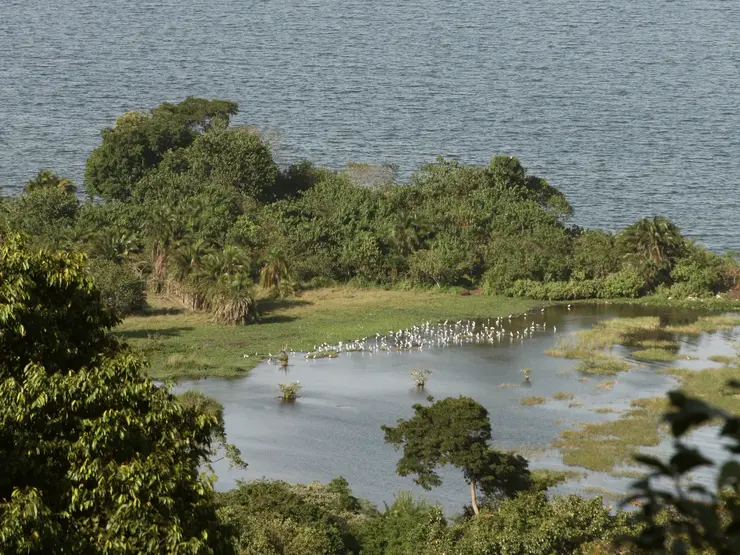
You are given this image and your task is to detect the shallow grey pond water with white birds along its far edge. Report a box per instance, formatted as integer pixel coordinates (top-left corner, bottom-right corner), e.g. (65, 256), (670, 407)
(175, 305), (733, 512)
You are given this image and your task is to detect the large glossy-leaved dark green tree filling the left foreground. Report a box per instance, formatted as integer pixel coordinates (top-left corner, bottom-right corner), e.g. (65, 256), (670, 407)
(0, 236), (233, 554)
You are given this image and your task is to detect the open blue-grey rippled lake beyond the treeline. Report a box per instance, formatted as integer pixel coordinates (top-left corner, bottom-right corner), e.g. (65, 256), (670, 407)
(0, 0), (740, 251)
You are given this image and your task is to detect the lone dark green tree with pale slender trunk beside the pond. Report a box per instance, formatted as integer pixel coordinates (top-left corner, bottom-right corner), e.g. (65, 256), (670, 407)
(381, 396), (530, 515)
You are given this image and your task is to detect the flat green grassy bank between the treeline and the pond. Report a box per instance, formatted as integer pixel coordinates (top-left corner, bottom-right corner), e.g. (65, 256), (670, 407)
(115, 287), (541, 379)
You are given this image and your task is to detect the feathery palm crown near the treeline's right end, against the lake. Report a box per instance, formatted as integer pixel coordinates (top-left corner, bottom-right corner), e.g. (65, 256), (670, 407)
(617, 216), (686, 268)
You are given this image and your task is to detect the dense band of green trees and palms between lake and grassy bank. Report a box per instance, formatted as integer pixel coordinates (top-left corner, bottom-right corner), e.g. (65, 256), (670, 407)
(0, 98), (740, 323)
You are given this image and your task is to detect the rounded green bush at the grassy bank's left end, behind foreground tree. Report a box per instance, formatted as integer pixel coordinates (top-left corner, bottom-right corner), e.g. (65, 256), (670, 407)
(88, 258), (146, 316)
